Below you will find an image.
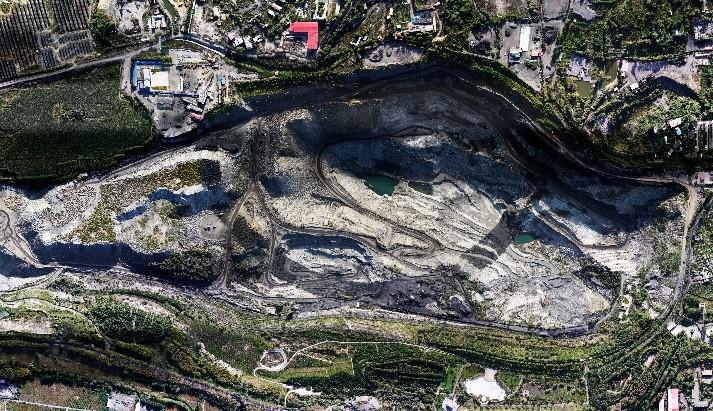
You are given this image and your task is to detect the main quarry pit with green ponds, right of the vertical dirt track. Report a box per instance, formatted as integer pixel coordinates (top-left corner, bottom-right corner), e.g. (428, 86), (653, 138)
(246, 73), (683, 328)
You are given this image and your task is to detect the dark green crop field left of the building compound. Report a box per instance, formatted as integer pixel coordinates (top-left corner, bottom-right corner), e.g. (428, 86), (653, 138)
(0, 66), (155, 181)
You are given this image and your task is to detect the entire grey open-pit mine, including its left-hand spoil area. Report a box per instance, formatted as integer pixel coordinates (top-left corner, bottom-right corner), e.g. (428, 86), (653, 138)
(0, 69), (684, 332)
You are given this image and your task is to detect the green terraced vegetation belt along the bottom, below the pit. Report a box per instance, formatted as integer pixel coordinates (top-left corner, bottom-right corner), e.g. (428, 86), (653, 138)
(0, 278), (713, 409)
